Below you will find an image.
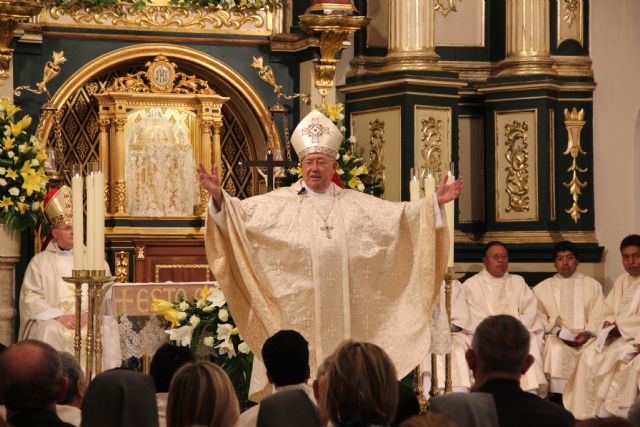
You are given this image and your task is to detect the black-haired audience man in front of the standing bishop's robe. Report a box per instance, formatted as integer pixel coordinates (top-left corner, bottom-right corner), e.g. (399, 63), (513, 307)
(237, 330), (316, 427)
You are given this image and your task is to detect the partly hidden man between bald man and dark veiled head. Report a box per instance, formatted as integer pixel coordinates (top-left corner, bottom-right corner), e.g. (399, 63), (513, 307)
(56, 351), (87, 426)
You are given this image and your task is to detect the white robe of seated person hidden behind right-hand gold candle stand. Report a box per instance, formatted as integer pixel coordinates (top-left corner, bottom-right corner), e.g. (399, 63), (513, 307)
(421, 280), (474, 394)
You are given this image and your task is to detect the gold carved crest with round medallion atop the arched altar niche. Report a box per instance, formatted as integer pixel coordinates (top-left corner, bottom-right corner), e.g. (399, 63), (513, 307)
(106, 55), (215, 94)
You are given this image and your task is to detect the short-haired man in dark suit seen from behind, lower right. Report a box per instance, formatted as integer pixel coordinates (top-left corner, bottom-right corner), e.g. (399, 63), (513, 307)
(431, 314), (575, 427)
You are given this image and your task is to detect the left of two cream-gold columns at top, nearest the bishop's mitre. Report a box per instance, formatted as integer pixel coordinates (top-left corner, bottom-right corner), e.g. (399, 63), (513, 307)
(383, 0), (440, 71)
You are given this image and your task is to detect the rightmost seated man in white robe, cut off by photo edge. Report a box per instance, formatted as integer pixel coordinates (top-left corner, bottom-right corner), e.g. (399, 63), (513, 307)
(563, 234), (640, 419)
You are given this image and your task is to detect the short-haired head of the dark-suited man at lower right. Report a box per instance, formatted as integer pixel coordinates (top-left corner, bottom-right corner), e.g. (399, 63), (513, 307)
(466, 314), (533, 385)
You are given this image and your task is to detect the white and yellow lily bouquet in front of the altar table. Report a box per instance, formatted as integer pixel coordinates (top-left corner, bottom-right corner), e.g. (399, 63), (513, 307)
(151, 285), (253, 401)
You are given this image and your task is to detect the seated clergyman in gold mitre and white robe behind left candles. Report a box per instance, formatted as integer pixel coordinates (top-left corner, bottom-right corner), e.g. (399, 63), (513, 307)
(19, 185), (109, 354)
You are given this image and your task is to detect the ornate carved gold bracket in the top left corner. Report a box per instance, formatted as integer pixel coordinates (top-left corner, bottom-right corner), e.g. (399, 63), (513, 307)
(0, 0), (42, 86)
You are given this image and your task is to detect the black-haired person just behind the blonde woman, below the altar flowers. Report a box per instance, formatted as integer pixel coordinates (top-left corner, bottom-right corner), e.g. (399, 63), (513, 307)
(149, 343), (195, 427)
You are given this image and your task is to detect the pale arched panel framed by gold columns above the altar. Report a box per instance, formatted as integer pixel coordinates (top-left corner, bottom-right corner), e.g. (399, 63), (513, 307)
(125, 117), (199, 216)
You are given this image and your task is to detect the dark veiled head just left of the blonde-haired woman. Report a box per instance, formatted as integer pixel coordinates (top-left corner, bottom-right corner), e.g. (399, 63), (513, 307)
(80, 368), (158, 427)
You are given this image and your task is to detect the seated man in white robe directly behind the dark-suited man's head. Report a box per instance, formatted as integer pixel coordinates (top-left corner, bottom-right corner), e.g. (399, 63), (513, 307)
(463, 241), (548, 396)
